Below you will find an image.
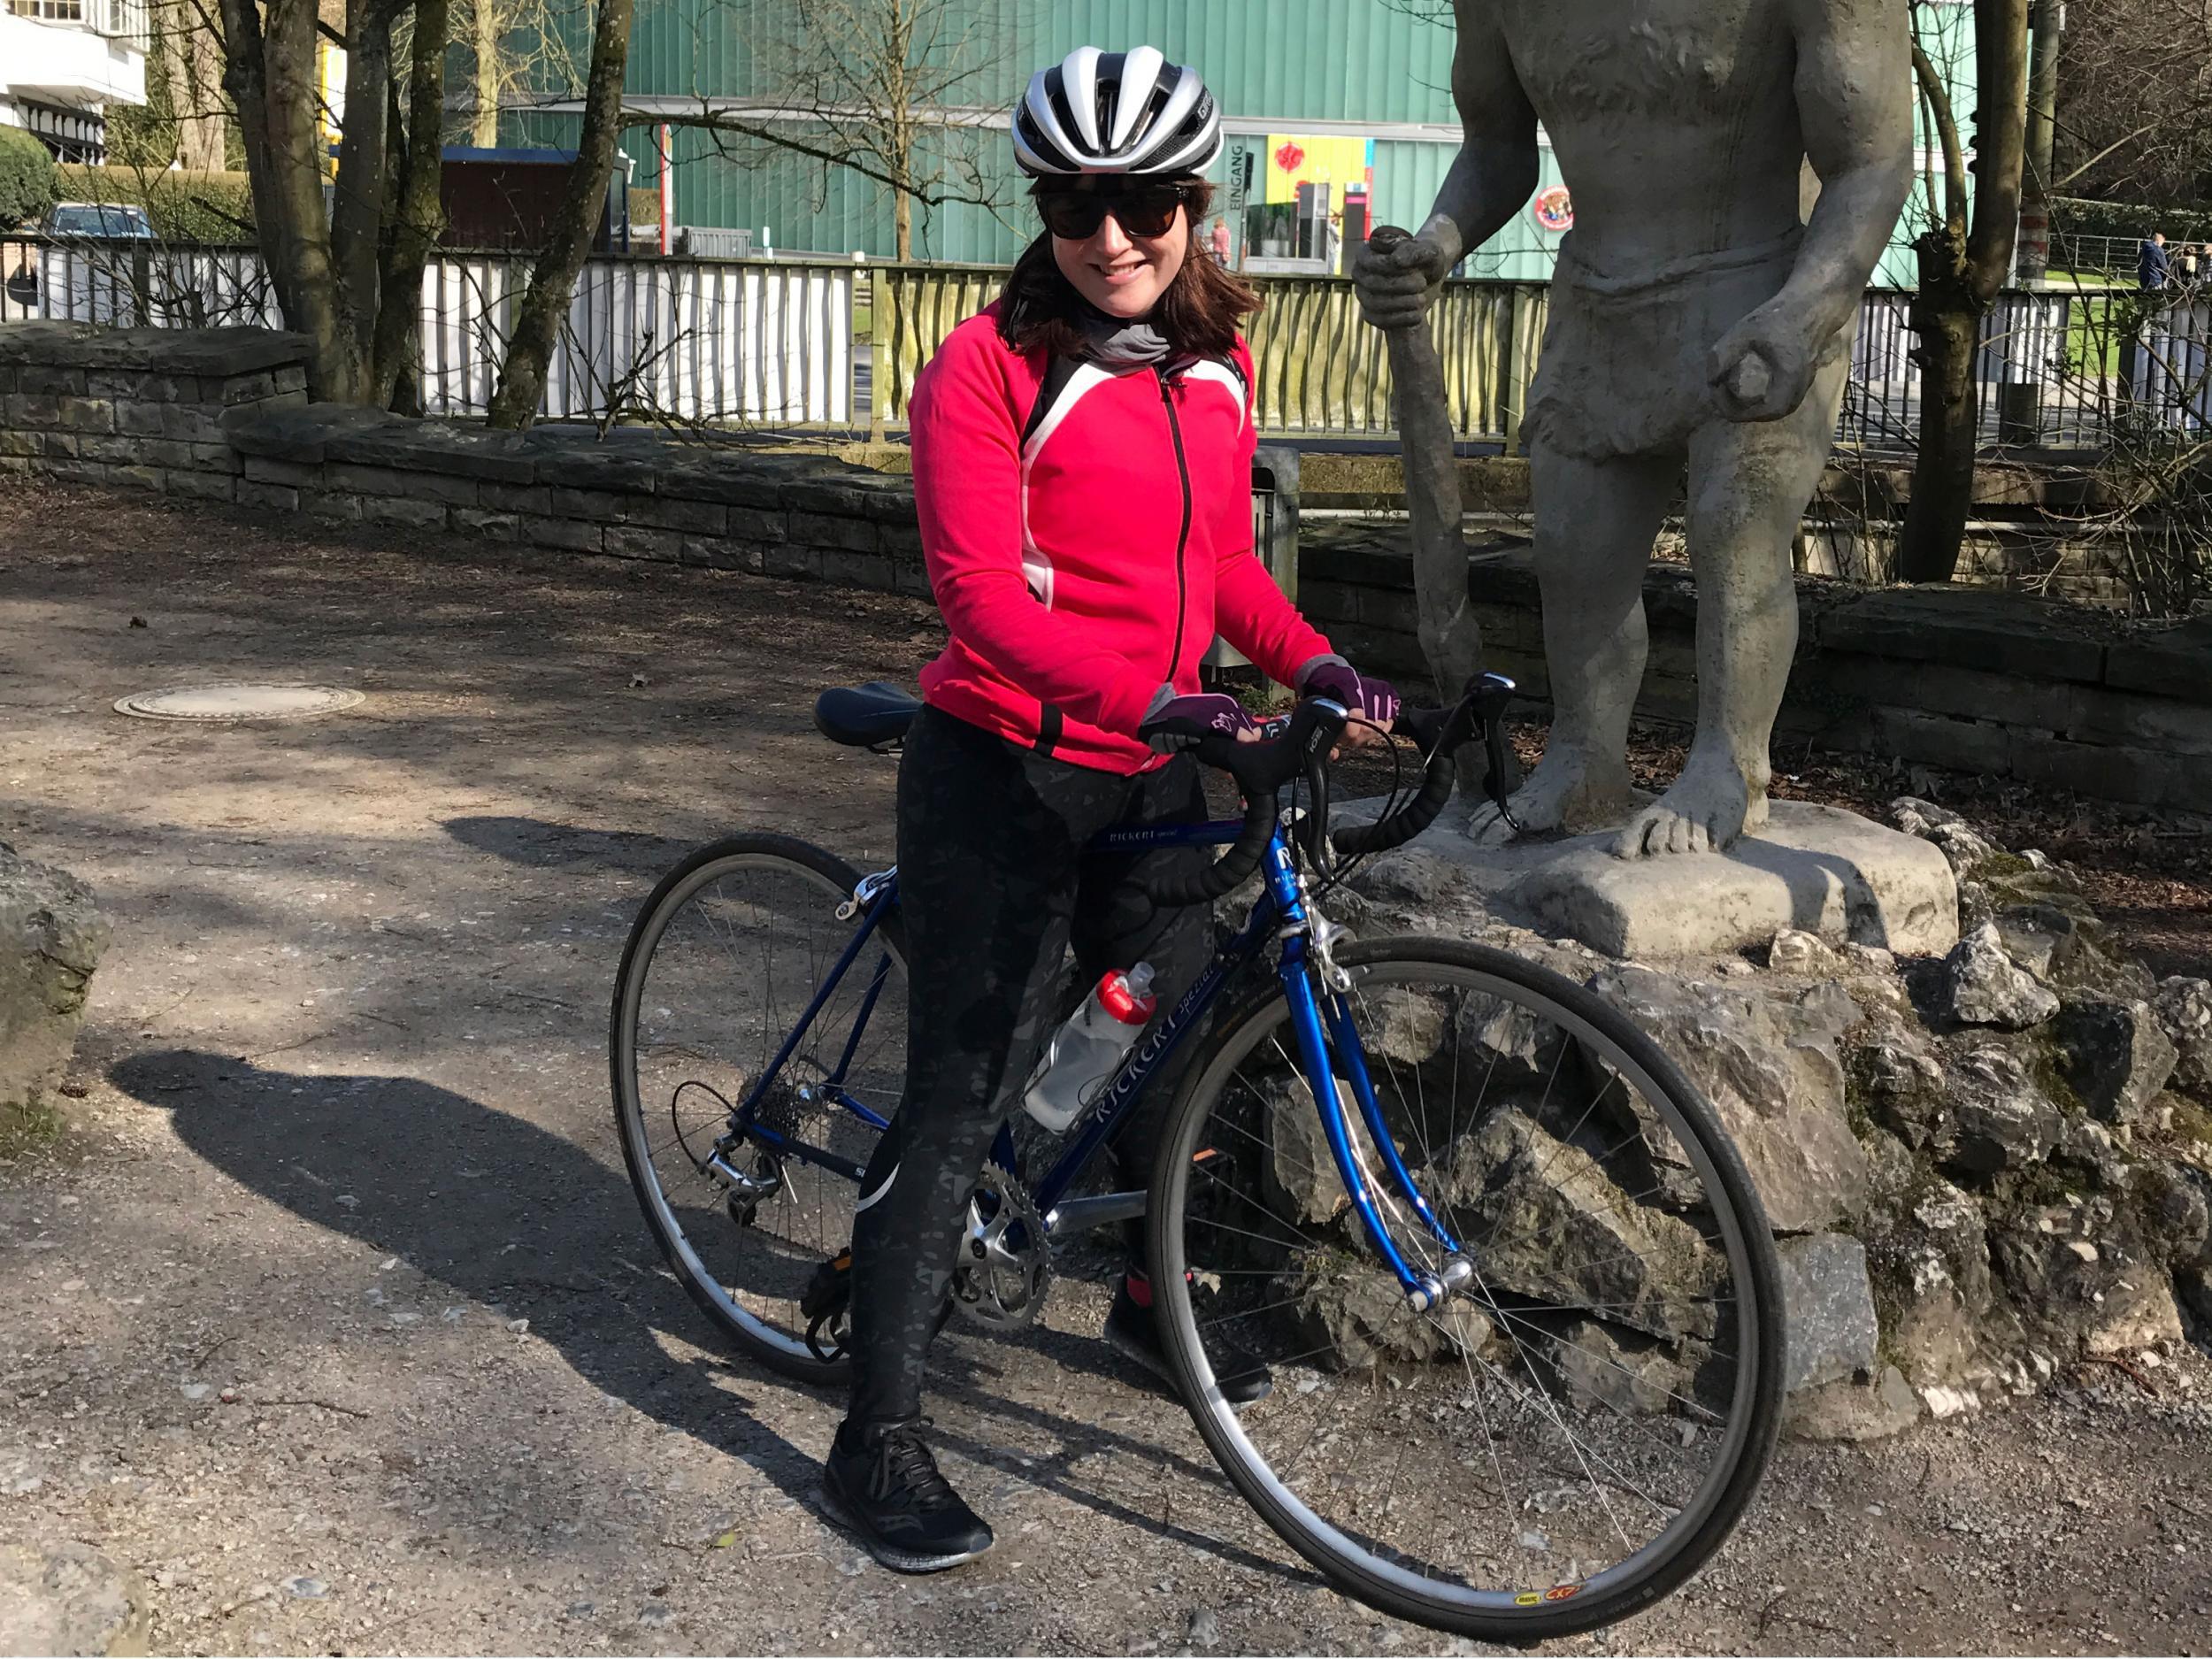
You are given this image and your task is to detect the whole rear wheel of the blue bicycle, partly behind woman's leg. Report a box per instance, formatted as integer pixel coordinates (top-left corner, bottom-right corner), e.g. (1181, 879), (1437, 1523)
(609, 836), (907, 1383)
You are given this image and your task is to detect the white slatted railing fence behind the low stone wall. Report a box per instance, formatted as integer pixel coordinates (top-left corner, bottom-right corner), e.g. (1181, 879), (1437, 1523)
(0, 237), (2212, 451)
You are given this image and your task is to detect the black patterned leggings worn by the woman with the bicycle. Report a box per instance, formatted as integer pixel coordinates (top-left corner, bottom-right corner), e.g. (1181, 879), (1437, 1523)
(849, 708), (1212, 1427)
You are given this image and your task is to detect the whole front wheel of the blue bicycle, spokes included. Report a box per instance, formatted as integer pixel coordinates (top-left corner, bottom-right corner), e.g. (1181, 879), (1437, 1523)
(1150, 938), (1783, 1644)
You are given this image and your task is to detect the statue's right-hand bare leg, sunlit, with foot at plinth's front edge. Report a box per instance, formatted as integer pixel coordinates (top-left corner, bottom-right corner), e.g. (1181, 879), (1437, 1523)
(1615, 361), (1847, 858)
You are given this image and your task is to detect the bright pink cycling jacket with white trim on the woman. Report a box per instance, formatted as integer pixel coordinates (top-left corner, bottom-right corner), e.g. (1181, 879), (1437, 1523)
(914, 305), (1330, 774)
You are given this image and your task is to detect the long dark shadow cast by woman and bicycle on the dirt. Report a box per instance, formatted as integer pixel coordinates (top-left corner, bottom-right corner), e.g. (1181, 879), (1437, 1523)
(111, 1048), (1318, 1584)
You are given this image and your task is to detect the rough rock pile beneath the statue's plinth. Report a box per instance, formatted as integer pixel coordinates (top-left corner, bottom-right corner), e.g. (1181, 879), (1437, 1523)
(1303, 799), (2212, 1438)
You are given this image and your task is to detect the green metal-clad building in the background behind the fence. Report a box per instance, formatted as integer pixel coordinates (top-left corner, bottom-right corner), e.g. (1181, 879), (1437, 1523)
(511, 0), (1973, 286)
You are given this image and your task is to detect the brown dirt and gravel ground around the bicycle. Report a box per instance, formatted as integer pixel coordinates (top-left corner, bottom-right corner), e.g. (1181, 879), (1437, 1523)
(0, 482), (2212, 1655)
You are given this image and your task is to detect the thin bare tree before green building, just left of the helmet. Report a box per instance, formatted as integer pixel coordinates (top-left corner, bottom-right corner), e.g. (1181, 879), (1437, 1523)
(646, 0), (1007, 259)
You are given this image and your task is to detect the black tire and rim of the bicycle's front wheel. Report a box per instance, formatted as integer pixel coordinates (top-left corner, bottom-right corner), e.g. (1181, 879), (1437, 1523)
(1148, 938), (1786, 1646)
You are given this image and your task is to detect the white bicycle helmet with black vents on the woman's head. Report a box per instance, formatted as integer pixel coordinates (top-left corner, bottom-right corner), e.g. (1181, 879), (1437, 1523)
(1013, 47), (1221, 180)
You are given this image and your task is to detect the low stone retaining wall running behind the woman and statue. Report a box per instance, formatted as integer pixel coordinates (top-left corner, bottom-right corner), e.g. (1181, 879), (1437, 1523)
(0, 323), (2212, 810)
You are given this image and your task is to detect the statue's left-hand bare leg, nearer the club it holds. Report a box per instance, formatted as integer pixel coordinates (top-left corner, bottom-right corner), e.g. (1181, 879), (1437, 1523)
(1469, 441), (1681, 843)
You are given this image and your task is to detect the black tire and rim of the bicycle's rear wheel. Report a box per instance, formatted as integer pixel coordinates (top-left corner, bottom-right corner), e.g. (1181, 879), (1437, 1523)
(609, 834), (905, 1385)
